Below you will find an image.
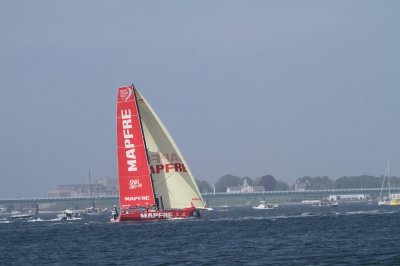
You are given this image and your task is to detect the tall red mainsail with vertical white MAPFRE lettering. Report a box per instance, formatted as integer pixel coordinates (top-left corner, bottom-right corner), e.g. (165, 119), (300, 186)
(117, 86), (155, 208)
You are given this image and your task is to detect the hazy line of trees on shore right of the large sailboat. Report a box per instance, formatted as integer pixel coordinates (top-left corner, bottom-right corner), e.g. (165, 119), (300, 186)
(196, 174), (400, 193)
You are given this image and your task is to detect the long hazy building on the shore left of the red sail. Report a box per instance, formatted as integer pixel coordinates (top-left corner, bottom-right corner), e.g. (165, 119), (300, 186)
(47, 178), (119, 198)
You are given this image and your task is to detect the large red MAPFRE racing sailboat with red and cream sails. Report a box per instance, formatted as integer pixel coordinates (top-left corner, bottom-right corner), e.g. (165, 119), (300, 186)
(111, 85), (205, 222)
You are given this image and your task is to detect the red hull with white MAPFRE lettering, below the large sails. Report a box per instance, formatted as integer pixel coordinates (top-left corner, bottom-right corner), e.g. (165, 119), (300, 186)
(111, 207), (200, 222)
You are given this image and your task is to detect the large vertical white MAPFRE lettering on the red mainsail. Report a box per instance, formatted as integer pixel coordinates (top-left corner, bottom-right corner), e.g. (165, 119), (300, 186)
(121, 109), (137, 172)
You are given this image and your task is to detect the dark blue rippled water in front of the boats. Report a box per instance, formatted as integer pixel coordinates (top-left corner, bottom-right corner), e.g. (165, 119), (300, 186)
(0, 203), (400, 265)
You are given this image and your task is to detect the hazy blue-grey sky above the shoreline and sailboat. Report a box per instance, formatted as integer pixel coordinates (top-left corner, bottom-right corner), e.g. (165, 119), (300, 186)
(0, 0), (400, 198)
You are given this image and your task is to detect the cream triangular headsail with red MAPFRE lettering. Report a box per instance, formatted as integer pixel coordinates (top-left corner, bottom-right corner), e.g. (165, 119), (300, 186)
(137, 92), (205, 209)
